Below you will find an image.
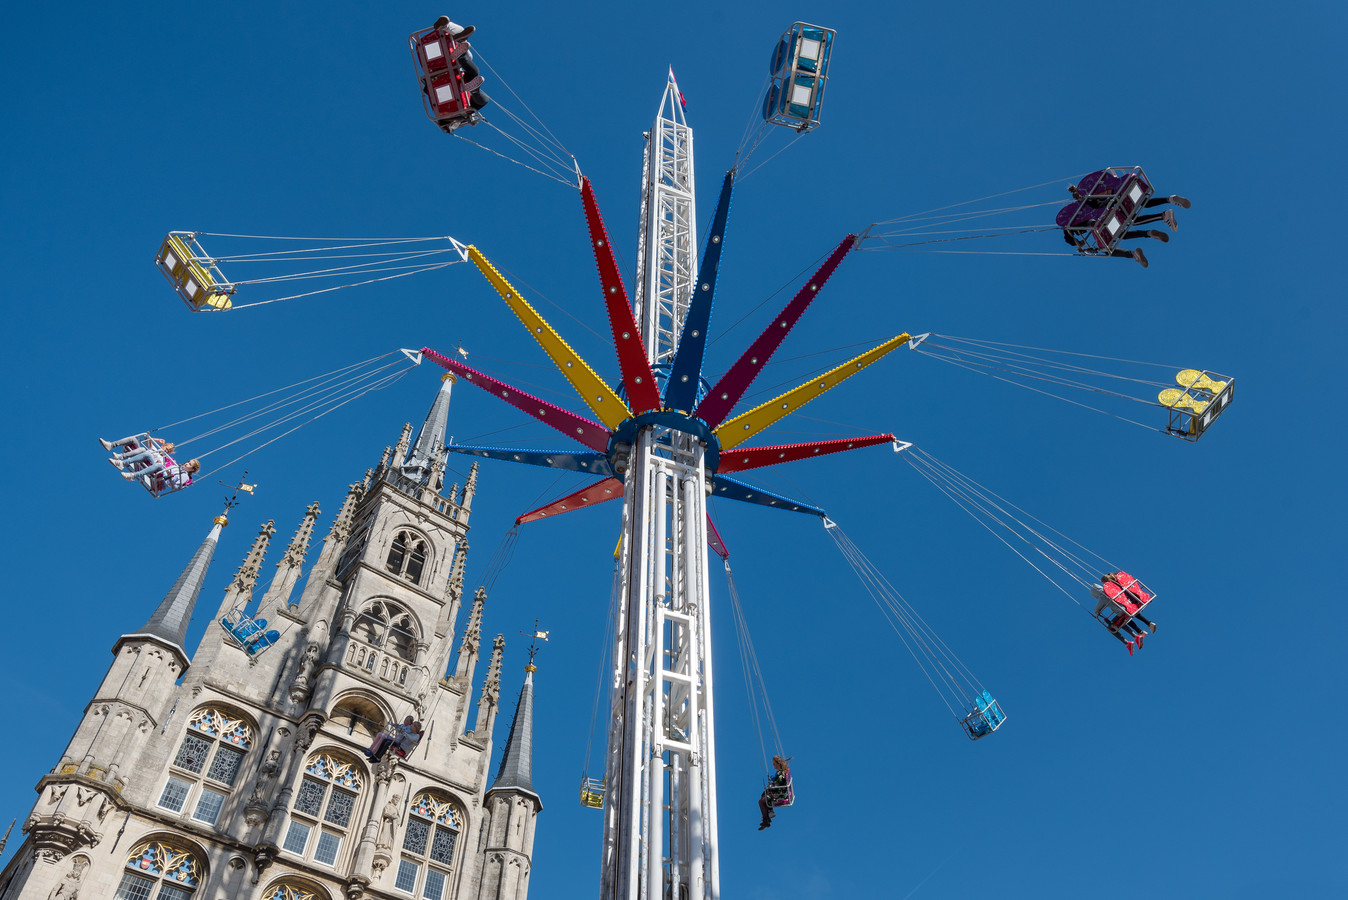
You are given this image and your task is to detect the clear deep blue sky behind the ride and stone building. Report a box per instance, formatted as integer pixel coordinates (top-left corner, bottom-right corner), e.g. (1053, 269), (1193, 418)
(0, 1), (1348, 900)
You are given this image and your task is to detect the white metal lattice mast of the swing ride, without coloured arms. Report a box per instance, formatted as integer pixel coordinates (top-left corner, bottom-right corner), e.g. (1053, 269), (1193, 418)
(600, 73), (720, 900)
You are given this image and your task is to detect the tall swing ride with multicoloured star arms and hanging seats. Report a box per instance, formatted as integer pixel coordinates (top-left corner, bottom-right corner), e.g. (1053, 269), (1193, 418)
(109, 18), (1235, 900)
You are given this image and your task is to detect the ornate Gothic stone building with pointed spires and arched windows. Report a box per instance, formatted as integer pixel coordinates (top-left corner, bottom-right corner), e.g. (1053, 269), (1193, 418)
(0, 376), (542, 900)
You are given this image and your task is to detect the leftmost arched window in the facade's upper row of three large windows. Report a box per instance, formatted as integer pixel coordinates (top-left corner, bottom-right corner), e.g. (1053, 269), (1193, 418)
(159, 706), (253, 825)
